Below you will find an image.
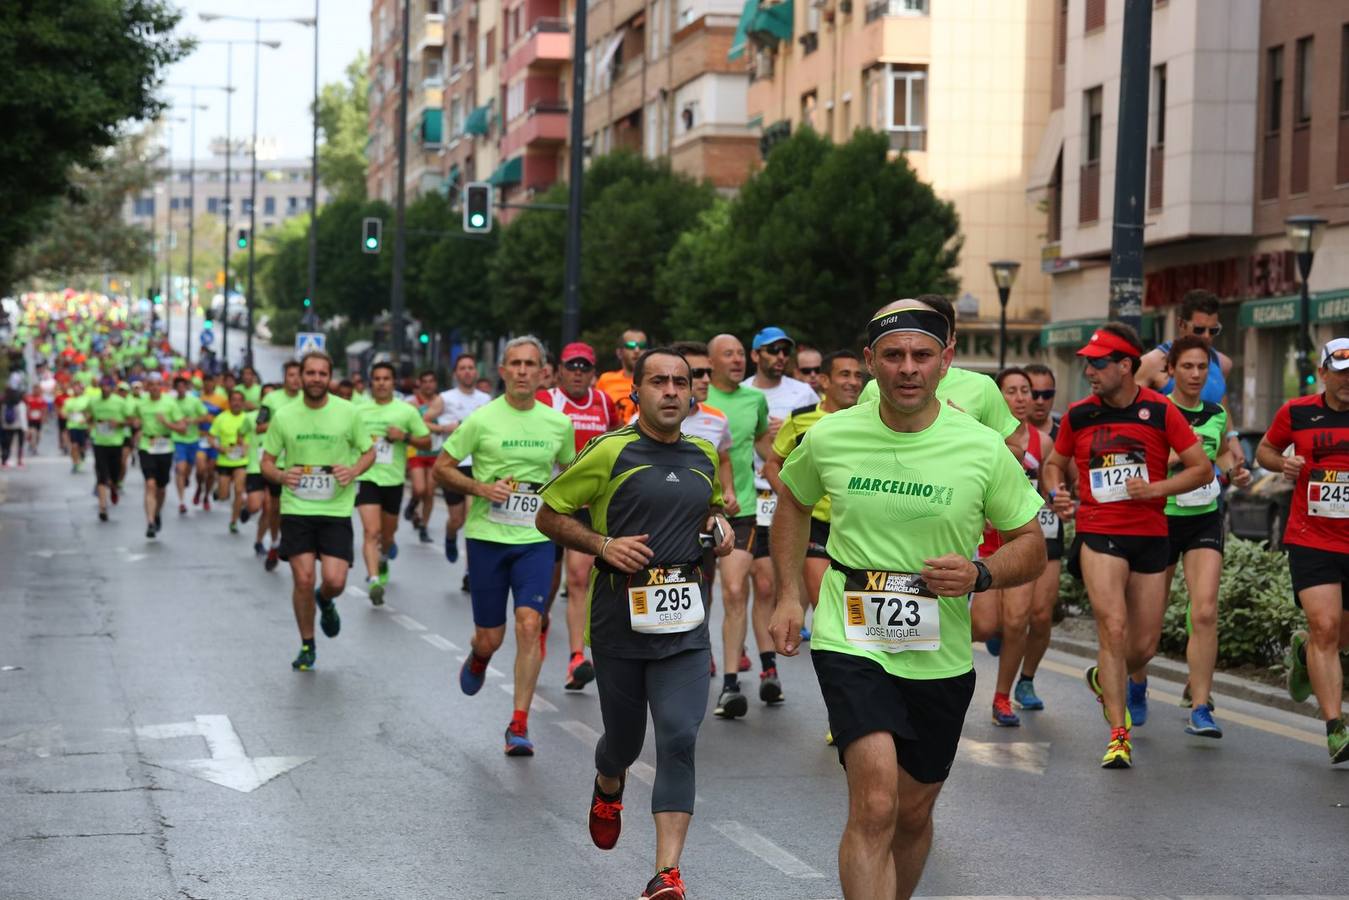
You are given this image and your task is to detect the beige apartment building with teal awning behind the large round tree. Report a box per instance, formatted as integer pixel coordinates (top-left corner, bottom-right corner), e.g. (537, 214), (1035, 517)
(733, 0), (1054, 371)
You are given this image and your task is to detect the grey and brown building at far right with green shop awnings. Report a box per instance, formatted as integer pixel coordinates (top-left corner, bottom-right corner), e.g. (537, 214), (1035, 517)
(1028, 0), (1349, 428)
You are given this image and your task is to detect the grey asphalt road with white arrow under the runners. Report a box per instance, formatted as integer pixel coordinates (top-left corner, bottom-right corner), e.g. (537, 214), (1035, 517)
(0, 453), (1349, 900)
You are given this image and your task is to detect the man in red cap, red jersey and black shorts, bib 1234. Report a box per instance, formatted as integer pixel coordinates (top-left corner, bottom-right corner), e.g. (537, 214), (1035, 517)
(1041, 322), (1213, 769)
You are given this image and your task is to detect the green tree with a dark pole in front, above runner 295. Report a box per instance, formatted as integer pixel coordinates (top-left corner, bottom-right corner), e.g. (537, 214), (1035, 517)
(490, 151), (716, 347)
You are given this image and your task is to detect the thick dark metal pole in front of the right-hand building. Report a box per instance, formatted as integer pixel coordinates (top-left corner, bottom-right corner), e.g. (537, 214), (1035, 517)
(1110, 0), (1153, 331)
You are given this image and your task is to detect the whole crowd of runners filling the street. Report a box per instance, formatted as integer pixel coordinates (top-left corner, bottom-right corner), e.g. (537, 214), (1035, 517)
(0, 291), (1349, 900)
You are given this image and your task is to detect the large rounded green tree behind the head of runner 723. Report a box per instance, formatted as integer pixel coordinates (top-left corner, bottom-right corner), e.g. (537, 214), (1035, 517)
(657, 128), (960, 348)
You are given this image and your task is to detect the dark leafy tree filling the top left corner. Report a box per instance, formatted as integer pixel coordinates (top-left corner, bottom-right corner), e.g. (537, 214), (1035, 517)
(0, 0), (192, 293)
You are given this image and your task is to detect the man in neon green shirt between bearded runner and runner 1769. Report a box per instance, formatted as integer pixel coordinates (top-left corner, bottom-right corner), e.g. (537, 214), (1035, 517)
(356, 363), (430, 606)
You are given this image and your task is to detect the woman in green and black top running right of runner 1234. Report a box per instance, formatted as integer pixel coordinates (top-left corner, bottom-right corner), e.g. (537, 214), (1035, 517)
(1129, 335), (1251, 738)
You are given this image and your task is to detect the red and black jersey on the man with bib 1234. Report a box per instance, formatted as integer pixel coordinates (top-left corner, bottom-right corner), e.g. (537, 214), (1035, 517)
(1054, 387), (1199, 537)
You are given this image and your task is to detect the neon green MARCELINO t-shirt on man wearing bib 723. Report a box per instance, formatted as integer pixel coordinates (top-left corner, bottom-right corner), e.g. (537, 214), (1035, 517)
(782, 403), (1044, 679)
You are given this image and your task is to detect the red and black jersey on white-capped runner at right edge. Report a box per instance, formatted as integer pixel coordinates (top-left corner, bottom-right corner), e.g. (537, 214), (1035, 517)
(1265, 394), (1349, 553)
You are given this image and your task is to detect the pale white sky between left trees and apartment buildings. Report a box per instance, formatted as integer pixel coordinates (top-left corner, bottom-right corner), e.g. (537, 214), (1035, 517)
(161, 0), (370, 159)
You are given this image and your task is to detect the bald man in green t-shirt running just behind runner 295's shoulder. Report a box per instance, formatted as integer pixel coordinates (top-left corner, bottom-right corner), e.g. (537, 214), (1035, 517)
(707, 335), (781, 719)
